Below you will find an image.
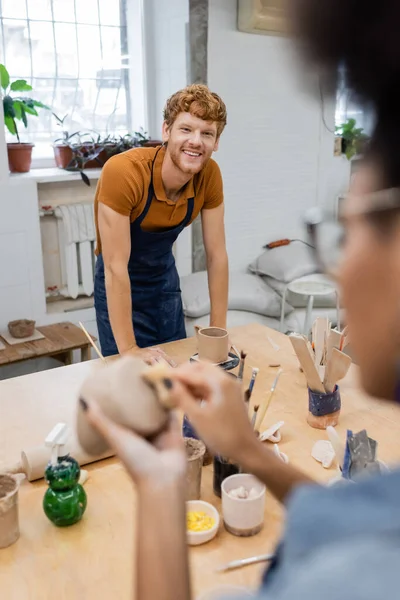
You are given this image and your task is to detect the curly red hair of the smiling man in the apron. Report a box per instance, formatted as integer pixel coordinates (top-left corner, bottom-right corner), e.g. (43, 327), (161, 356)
(164, 84), (227, 137)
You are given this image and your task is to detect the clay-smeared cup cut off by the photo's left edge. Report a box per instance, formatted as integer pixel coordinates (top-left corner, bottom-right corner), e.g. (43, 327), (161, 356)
(0, 475), (19, 548)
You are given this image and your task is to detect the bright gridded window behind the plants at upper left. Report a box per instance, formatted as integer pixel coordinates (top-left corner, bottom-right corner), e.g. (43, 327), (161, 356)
(0, 0), (130, 157)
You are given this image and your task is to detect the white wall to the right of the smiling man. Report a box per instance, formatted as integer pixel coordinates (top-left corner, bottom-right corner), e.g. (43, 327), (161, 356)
(208, 0), (348, 270)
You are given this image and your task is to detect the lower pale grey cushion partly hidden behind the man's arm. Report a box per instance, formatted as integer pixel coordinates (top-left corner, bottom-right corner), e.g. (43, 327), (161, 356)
(181, 271), (293, 319)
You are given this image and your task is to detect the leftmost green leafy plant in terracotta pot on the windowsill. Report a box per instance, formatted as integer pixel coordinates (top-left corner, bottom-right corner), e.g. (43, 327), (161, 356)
(0, 64), (49, 173)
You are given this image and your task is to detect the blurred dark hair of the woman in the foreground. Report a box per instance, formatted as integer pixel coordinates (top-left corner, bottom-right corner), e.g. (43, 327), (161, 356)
(290, 0), (400, 187)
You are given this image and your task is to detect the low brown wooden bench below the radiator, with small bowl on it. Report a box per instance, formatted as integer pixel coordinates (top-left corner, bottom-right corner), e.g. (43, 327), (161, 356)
(0, 323), (96, 366)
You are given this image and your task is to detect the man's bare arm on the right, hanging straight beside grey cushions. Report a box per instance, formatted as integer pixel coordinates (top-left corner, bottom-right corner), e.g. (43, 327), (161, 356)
(201, 204), (229, 328)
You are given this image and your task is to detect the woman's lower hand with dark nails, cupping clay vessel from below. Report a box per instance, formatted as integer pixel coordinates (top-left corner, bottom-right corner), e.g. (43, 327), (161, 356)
(81, 400), (187, 487)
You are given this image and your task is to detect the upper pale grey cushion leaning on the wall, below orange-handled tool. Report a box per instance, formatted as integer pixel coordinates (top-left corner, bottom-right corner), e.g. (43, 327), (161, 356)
(249, 241), (318, 283)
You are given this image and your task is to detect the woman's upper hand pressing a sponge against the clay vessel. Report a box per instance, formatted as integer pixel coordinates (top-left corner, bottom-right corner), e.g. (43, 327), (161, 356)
(170, 363), (259, 462)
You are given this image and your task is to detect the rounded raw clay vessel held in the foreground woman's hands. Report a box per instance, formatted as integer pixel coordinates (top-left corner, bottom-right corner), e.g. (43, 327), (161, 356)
(77, 356), (172, 455)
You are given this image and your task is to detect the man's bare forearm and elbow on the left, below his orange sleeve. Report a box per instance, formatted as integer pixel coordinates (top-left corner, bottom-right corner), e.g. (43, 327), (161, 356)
(98, 202), (136, 354)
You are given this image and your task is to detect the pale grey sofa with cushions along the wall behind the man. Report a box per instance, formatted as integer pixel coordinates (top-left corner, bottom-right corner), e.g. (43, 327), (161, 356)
(181, 242), (342, 336)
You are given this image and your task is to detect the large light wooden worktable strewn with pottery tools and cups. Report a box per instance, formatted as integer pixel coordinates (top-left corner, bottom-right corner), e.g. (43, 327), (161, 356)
(0, 325), (400, 600)
